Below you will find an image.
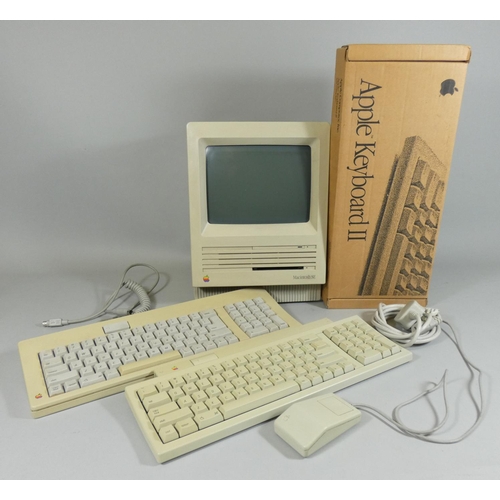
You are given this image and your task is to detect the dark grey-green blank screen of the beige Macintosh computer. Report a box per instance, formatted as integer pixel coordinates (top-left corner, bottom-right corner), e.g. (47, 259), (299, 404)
(206, 145), (311, 224)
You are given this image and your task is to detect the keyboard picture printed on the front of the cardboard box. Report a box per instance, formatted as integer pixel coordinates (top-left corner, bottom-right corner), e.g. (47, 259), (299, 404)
(359, 136), (446, 295)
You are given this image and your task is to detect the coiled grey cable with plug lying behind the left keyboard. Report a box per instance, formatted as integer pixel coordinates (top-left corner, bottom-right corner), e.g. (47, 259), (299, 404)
(42, 264), (160, 327)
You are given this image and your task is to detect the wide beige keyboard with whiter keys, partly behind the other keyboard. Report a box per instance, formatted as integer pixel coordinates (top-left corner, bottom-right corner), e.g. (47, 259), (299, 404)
(19, 289), (300, 417)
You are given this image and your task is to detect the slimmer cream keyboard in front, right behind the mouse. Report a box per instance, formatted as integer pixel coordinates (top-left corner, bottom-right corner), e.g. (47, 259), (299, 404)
(125, 316), (412, 462)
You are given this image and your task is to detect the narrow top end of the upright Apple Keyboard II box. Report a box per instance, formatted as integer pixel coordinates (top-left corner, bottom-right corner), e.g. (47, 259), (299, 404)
(346, 44), (471, 62)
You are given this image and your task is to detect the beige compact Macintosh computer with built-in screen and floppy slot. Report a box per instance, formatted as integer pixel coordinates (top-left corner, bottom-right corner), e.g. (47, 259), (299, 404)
(187, 122), (330, 302)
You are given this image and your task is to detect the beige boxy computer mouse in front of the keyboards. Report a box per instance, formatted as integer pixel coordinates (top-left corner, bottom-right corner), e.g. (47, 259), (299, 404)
(274, 394), (361, 457)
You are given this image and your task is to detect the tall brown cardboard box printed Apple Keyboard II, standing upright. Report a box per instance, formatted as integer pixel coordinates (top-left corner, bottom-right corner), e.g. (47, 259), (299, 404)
(323, 45), (470, 308)
